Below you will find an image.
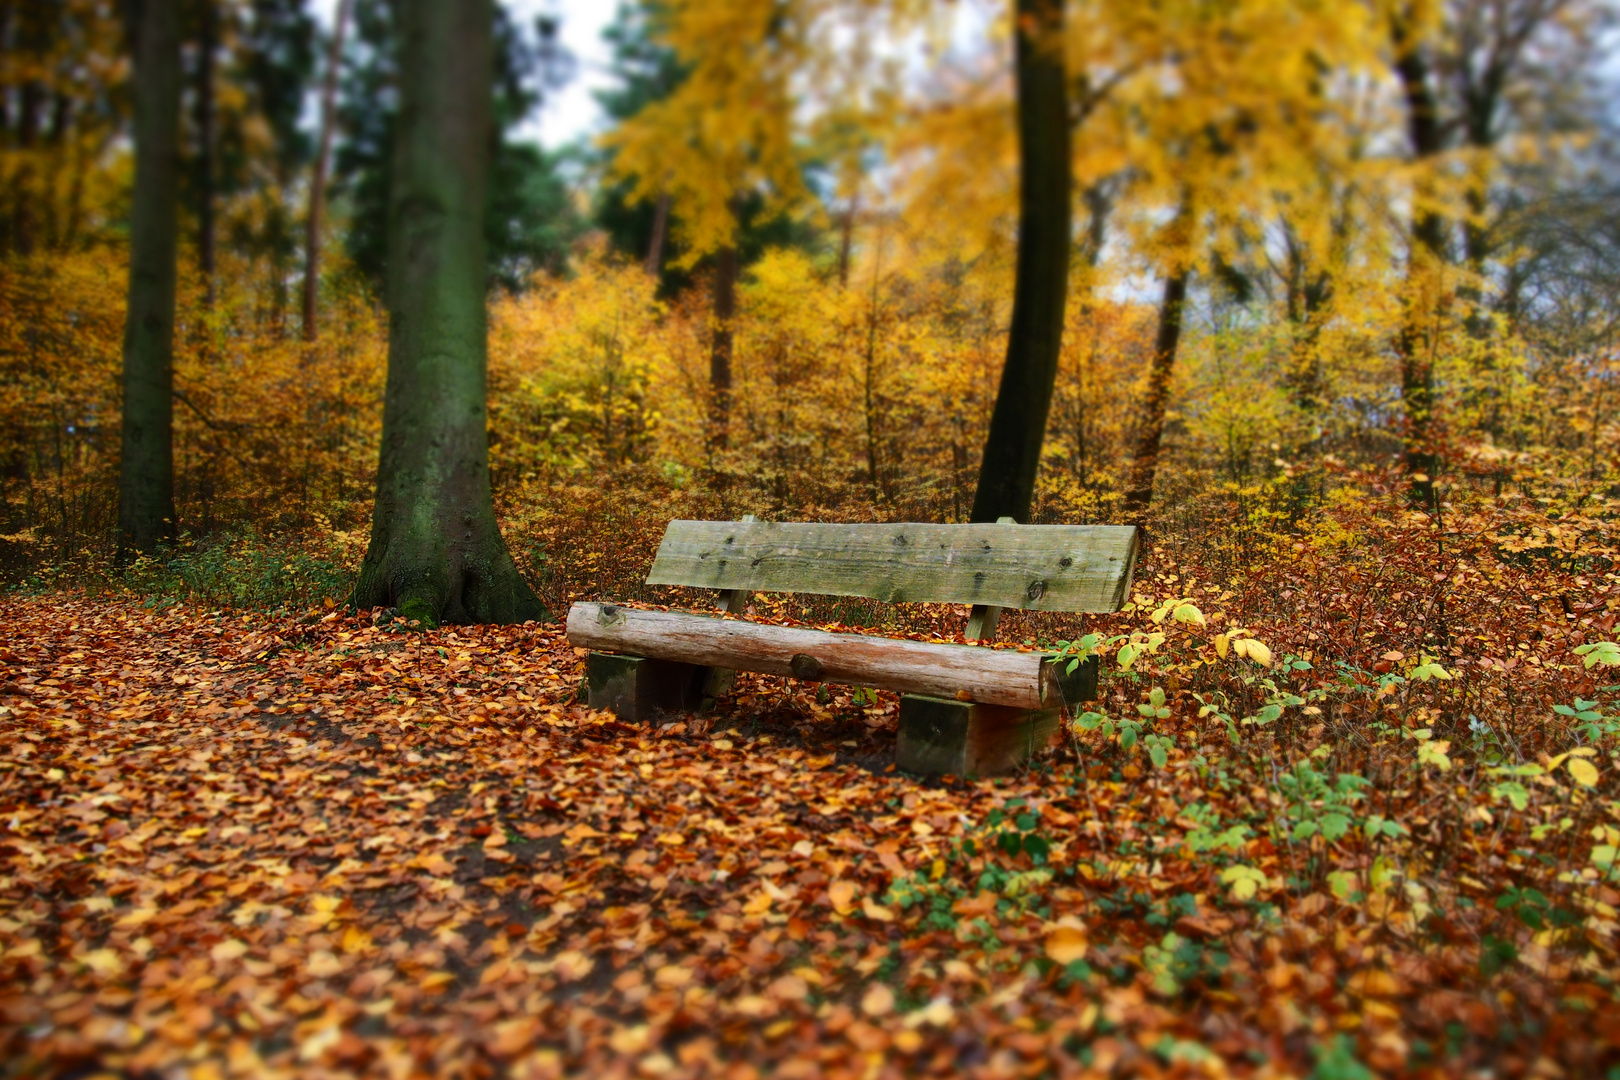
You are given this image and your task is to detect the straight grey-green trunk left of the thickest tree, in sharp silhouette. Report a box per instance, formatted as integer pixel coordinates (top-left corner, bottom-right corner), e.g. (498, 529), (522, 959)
(118, 0), (180, 560)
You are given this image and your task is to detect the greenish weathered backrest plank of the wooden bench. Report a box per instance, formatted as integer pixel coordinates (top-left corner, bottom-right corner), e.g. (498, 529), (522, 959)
(646, 521), (1137, 612)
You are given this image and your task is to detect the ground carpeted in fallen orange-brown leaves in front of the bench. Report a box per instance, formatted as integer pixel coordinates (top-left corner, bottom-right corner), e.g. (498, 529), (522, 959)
(0, 573), (1620, 1080)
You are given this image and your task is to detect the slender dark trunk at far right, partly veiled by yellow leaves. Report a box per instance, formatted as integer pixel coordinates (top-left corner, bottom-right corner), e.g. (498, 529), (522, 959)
(1392, 13), (1445, 507)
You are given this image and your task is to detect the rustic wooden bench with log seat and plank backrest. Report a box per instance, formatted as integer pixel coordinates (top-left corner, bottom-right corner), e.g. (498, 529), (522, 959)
(569, 518), (1137, 777)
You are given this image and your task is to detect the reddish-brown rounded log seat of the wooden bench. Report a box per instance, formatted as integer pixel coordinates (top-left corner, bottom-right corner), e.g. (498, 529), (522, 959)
(569, 604), (1085, 709)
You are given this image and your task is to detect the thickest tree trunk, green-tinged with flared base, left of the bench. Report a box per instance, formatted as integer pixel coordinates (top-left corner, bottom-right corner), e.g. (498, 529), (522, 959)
(353, 0), (548, 623)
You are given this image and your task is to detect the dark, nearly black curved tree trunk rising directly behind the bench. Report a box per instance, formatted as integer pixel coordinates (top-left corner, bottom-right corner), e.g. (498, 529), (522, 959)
(970, 0), (1072, 521)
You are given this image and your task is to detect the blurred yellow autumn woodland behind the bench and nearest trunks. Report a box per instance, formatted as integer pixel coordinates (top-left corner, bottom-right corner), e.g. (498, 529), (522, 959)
(0, 0), (1620, 606)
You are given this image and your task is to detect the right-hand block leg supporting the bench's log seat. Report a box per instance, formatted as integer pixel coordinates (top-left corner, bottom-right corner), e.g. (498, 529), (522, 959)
(894, 695), (1061, 779)
